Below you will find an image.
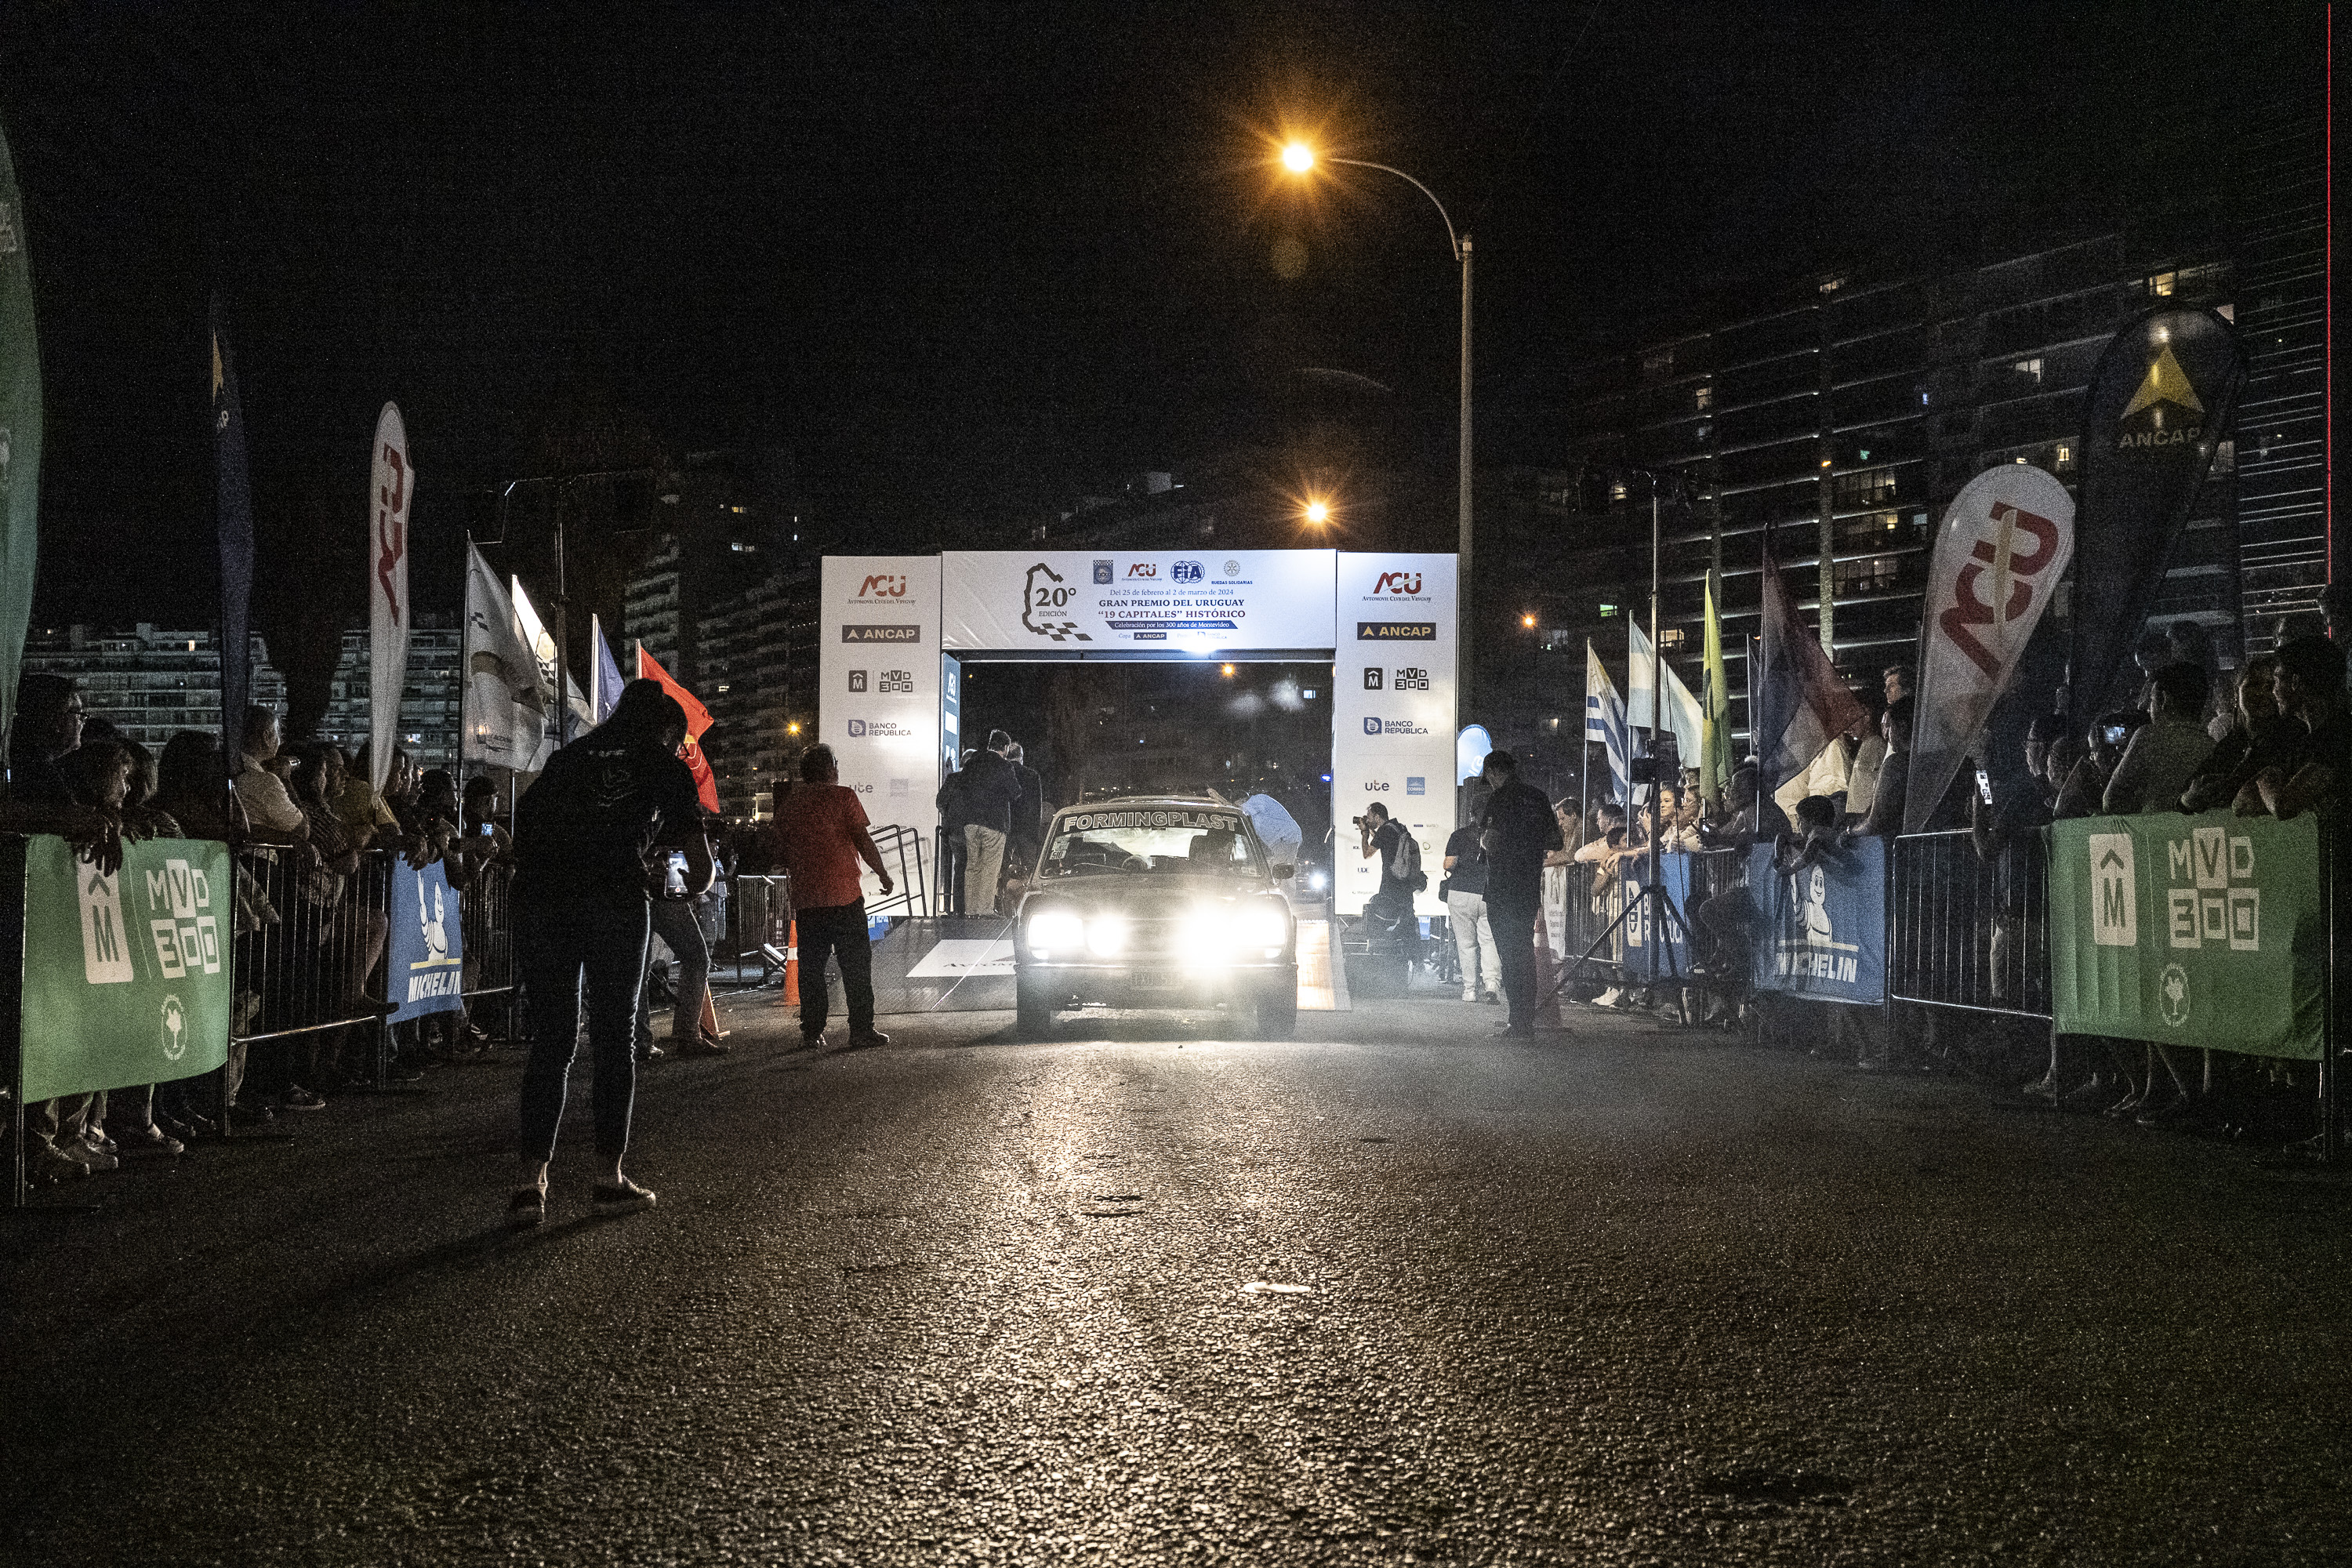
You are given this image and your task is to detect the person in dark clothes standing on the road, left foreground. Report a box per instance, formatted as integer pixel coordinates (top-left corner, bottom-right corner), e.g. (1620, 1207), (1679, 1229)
(508, 680), (713, 1225)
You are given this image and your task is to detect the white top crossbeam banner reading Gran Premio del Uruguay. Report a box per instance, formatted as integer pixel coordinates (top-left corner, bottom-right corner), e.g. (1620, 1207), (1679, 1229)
(941, 548), (1345, 659)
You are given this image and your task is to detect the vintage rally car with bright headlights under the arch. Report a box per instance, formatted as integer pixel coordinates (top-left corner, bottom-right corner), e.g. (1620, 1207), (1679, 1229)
(1014, 794), (1298, 1039)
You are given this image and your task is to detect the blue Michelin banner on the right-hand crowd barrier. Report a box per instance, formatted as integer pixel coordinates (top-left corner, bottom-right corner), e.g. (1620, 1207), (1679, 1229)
(1748, 839), (1886, 1006)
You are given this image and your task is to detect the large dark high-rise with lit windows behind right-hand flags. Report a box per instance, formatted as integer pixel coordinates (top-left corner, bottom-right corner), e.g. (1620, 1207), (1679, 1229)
(1477, 100), (2326, 760)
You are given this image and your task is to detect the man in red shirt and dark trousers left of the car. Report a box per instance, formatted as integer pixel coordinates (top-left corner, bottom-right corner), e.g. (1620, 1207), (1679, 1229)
(776, 746), (891, 1051)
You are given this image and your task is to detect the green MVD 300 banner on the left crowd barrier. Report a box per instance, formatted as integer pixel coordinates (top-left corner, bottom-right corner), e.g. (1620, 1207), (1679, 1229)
(21, 834), (238, 1102)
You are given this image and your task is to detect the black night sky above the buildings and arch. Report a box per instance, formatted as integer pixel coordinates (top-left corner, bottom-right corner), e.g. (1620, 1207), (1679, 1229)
(0, 0), (2319, 639)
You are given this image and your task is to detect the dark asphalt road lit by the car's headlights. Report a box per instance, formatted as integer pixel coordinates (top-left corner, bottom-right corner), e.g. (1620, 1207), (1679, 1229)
(0, 1001), (2352, 1566)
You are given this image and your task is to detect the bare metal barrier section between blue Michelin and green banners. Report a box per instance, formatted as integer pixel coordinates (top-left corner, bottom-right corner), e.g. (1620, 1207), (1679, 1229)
(1886, 832), (2051, 1018)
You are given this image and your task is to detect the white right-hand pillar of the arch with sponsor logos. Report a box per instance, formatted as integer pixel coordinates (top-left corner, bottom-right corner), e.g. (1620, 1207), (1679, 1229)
(1331, 553), (1456, 916)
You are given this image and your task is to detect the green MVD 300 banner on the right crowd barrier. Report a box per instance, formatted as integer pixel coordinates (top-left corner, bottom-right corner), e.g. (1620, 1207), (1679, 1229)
(2051, 811), (2328, 1060)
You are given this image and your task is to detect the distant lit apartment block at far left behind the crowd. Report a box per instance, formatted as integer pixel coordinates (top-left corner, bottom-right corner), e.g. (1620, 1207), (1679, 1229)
(24, 621), (287, 750)
